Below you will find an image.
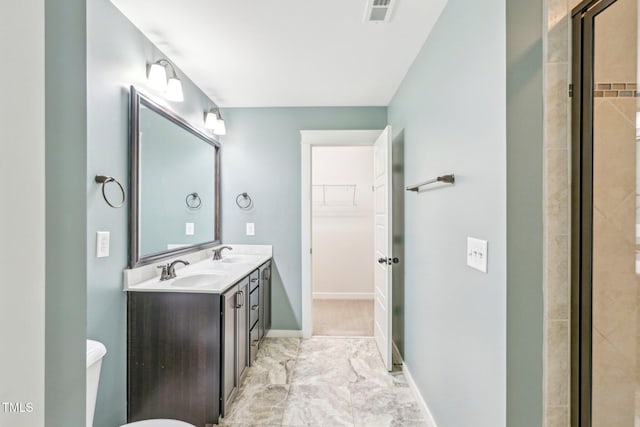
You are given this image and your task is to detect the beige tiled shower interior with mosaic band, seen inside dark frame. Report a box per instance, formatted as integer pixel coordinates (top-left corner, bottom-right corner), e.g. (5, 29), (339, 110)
(592, 0), (638, 427)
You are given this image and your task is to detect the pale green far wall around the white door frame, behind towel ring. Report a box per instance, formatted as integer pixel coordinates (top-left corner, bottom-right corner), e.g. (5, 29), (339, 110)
(221, 107), (387, 329)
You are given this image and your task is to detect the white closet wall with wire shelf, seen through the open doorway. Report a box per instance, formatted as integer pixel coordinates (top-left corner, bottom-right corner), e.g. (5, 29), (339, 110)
(312, 147), (374, 299)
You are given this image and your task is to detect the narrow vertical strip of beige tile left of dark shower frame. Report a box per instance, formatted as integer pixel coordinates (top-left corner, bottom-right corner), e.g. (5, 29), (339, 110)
(544, 0), (580, 427)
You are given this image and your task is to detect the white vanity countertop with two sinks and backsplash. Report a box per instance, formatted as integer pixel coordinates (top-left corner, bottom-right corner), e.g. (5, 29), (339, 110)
(124, 245), (272, 294)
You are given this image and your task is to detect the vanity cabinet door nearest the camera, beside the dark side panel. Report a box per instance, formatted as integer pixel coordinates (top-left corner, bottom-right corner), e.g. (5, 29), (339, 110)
(222, 285), (238, 416)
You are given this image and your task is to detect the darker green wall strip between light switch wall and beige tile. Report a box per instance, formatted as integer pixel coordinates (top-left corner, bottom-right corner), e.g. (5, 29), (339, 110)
(506, 0), (544, 427)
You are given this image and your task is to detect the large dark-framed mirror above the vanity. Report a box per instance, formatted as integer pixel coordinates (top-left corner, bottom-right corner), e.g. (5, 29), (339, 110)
(129, 87), (220, 268)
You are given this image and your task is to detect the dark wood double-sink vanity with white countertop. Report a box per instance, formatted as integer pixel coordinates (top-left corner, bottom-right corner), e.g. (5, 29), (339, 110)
(125, 246), (271, 427)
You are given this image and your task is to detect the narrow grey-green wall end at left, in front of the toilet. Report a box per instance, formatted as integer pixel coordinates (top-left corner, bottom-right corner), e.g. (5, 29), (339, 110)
(45, 0), (88, 426)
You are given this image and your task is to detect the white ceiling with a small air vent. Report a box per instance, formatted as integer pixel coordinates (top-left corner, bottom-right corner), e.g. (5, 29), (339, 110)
(112, 0), (446, 107)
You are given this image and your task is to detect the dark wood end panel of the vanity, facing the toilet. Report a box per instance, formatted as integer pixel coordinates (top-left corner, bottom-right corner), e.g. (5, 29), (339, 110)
(127, 292), (222, 427)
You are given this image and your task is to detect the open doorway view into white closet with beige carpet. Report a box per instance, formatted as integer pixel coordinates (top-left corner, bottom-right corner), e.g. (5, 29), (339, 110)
(311, 146), (375, 337)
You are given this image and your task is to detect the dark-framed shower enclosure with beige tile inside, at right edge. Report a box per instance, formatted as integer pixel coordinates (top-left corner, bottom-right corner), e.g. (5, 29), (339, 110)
(571, 0), (640, 427)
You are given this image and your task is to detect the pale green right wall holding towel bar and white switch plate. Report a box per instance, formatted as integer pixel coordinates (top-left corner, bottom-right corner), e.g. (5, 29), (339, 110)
(389, 0), (508, 427)
